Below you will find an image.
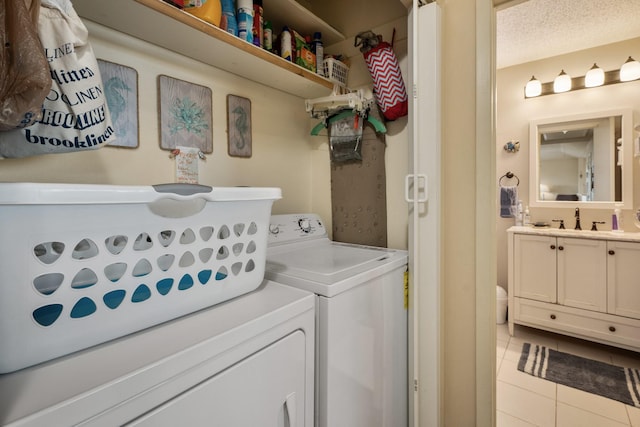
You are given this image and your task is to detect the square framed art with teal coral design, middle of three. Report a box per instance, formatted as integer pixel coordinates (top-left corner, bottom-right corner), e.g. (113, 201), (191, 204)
(158, 75), (213, 153)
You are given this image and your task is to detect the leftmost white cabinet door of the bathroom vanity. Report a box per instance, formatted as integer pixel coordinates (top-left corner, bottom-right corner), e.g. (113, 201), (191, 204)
(513, 234), (557, 303)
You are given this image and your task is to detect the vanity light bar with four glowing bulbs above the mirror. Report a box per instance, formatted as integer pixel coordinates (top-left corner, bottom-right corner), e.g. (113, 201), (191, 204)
(524, 56), (640, 98)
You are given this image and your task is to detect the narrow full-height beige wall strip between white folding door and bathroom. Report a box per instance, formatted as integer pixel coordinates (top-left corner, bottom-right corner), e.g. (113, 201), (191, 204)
(438, 0), (495, 426)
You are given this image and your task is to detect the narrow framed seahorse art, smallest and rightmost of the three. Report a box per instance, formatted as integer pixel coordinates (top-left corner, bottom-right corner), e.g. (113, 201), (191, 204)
(227, 95), (251, 157)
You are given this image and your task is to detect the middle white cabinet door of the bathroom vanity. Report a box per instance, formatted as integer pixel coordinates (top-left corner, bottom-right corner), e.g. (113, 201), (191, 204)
(557, 237), (607, 313)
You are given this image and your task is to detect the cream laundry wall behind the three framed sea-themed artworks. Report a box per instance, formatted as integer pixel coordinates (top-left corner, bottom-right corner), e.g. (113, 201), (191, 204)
(0, 23), (320, 217)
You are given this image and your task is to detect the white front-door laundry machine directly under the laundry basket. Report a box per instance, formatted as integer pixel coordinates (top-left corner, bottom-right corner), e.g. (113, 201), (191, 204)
(0, 280), (315, 427)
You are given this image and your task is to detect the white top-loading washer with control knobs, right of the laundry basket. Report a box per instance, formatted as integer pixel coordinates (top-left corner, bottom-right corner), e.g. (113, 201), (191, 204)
(265, 214), (408, 427)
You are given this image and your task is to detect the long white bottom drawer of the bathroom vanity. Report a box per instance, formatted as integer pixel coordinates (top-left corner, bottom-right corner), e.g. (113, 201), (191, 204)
(514, 298), (640, 351)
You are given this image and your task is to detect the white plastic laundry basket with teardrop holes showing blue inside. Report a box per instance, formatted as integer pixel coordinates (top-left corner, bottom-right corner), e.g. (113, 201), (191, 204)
(0, 183), (281, 373)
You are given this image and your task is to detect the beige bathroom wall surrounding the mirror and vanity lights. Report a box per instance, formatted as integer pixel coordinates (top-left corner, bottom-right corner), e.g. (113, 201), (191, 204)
(495, 38), (640, 289)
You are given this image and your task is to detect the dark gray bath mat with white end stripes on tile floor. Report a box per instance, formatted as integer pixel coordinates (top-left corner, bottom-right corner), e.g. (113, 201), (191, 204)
(518, 343), (640, 408)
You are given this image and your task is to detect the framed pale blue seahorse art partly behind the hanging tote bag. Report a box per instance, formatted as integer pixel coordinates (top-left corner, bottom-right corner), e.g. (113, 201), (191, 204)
(98, 59), (140, 148)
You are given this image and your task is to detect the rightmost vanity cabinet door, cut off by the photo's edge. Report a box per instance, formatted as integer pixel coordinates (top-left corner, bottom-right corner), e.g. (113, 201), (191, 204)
(607, 241), (640, 319)
